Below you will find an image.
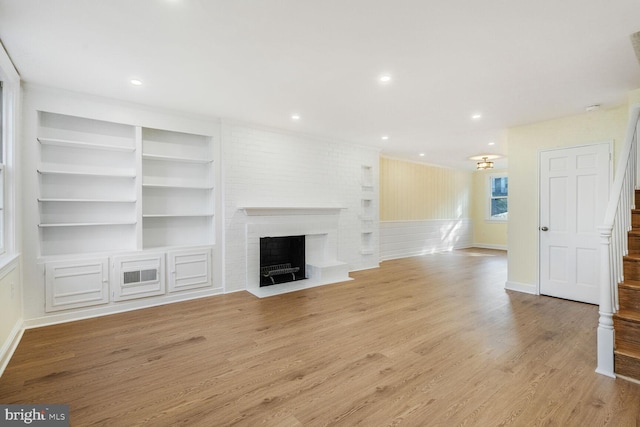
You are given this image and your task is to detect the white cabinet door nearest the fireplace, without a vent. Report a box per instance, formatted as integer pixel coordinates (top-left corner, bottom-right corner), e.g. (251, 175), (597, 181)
(168, 248), (211, 292)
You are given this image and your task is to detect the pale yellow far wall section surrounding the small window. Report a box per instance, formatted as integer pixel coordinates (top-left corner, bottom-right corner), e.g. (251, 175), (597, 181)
(471, 169), (504, 249)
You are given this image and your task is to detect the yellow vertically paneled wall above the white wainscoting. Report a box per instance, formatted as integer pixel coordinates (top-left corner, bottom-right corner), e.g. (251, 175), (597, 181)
(380, 157), (471, 221)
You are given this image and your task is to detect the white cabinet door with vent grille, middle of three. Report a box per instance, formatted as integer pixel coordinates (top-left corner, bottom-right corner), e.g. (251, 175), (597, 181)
(111, 252), (165, 301)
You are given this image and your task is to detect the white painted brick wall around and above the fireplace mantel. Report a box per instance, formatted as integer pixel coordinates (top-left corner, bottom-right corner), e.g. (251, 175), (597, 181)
(223, 122), (379, 292)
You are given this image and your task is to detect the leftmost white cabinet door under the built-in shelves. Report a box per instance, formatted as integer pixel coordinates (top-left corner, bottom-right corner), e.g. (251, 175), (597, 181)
(45, 258), (109, 312)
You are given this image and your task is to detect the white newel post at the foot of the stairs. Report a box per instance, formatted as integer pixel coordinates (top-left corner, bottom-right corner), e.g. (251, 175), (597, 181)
(596, 225), (616, 378)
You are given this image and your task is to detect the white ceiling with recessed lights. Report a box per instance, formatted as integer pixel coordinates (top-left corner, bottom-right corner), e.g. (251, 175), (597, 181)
(0, 0), (640, 169)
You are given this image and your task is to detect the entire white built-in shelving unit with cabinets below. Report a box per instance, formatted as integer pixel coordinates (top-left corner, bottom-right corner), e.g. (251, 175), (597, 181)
(35, 111), (215, 311)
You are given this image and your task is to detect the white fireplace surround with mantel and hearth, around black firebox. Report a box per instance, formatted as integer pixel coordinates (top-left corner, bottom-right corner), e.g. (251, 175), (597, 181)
(243, 207), (351, 297)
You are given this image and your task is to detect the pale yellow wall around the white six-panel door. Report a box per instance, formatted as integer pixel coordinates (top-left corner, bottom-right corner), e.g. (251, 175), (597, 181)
(507, 105), (628, 292)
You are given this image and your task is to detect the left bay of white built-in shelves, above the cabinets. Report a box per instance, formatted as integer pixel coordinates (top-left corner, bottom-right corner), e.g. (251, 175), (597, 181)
(37, 112), (137, 256)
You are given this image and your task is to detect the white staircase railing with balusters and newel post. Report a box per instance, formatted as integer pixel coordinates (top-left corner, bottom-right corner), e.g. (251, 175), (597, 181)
(596, 104), (640, 378)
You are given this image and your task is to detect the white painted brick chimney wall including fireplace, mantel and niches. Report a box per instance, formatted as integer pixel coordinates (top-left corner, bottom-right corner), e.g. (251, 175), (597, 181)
(222, 120), (380, 293)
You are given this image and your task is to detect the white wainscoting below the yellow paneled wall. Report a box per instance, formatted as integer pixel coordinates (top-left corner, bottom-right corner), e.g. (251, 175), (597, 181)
(380, 218), (473, 261)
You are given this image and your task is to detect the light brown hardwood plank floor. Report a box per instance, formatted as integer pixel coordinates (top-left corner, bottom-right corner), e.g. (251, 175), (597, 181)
(0, 249), (640, 427)
